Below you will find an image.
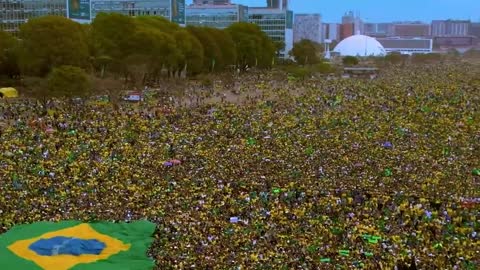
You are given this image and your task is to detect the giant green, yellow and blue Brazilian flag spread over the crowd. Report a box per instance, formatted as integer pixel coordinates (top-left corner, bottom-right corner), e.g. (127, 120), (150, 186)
(0, 221), (155, 270)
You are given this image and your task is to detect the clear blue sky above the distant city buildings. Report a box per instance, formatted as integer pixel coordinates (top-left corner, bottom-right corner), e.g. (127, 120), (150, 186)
(186, 0), (480, 22)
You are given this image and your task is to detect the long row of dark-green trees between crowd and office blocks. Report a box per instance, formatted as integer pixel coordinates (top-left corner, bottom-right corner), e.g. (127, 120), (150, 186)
(0, 13), (279, 87)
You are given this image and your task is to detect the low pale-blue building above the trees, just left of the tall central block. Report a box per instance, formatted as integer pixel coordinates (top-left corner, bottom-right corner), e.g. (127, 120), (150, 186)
(187, 4), (248, 29)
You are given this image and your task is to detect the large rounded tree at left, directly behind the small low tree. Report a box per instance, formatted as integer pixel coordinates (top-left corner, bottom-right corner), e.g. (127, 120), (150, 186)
(19, 16), (89, 76)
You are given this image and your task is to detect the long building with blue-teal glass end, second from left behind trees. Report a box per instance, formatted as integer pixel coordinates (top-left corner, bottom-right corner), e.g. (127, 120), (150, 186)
(90, 0), (186, 25)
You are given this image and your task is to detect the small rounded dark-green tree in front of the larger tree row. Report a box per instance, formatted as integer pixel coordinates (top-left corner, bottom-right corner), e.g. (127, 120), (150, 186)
(47, 66), (91, 97)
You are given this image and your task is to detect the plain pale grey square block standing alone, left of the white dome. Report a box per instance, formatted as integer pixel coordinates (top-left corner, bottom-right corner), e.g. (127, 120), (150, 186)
(293, 14), (322, 43)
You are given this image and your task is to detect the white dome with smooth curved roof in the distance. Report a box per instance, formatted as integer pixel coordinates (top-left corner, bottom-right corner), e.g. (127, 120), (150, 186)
(333, 35), (387, 57)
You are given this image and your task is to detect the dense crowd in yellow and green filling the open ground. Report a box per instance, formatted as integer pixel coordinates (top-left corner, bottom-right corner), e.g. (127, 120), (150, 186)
(0, 65), (480, 269)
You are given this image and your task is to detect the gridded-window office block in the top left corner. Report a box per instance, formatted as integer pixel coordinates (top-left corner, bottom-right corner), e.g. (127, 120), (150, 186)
(0, 0), (67, 33)
